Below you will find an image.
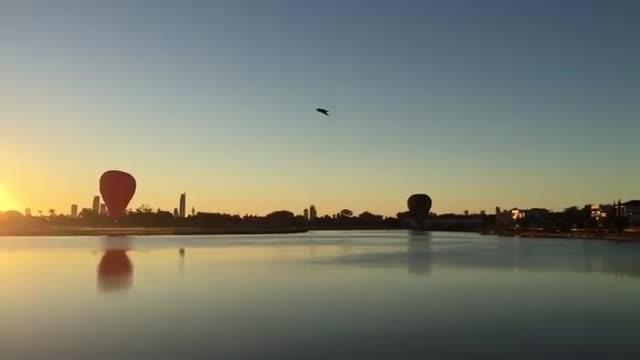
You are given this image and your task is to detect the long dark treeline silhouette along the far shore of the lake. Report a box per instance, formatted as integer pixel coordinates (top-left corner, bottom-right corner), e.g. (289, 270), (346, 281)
(0, 204), (630, 233)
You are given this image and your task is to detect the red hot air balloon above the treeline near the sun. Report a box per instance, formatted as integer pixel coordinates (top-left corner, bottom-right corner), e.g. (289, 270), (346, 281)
(100, 170), (136, 219)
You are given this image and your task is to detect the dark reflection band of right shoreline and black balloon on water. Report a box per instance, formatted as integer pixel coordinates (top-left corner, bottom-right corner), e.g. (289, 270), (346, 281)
(330, 232), (640, 277)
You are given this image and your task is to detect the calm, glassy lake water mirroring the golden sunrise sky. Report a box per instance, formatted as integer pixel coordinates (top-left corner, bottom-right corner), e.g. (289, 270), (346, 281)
(0, 231), (640, 359)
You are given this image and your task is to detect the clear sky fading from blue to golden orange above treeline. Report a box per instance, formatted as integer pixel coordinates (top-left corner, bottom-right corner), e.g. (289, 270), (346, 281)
(0, 0), (640, 215)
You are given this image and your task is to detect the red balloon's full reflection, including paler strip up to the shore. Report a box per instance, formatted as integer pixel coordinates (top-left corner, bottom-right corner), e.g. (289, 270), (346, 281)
(98, 236), (133, 292)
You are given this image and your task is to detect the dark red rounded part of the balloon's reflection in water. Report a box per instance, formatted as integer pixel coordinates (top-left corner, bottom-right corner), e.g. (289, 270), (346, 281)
(98, 249), (133, 291)
